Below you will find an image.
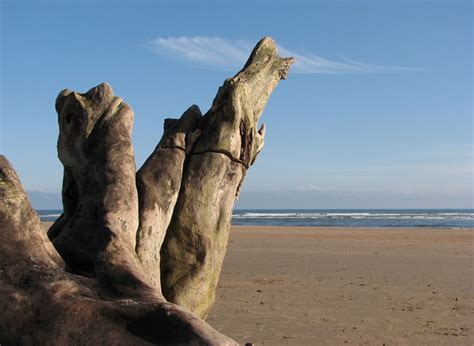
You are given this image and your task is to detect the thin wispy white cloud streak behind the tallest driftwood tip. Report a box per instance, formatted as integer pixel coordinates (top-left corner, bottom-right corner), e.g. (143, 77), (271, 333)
(149, 36), (417, 74)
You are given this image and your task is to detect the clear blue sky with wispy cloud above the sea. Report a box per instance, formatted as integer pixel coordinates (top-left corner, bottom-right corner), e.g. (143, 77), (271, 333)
(0, 0), (473, 208)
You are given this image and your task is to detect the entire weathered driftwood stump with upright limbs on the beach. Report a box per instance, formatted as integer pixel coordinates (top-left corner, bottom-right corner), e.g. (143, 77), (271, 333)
(0, 38), (293, 345)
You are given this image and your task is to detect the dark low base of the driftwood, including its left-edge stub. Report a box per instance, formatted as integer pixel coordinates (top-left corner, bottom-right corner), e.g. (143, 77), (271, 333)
(0, 155), (237, 345)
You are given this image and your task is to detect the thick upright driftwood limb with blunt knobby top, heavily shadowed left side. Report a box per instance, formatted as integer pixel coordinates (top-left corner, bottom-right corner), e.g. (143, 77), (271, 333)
(50, 83), (154, 294)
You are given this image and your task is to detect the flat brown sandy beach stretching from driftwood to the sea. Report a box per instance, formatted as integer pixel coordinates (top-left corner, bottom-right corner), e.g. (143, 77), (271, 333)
(45, 223), (474, 345)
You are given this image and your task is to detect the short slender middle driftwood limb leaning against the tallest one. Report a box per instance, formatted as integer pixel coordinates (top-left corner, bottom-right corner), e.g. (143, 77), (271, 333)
(136, 106), (202, 290)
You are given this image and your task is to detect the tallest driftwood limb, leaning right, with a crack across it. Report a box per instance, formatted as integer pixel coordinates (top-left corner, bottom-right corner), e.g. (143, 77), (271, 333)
(161, 38), (293, 318)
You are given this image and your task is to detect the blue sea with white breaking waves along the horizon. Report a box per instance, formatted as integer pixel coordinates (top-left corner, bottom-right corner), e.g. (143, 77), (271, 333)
(38, 209), (474, 228)
